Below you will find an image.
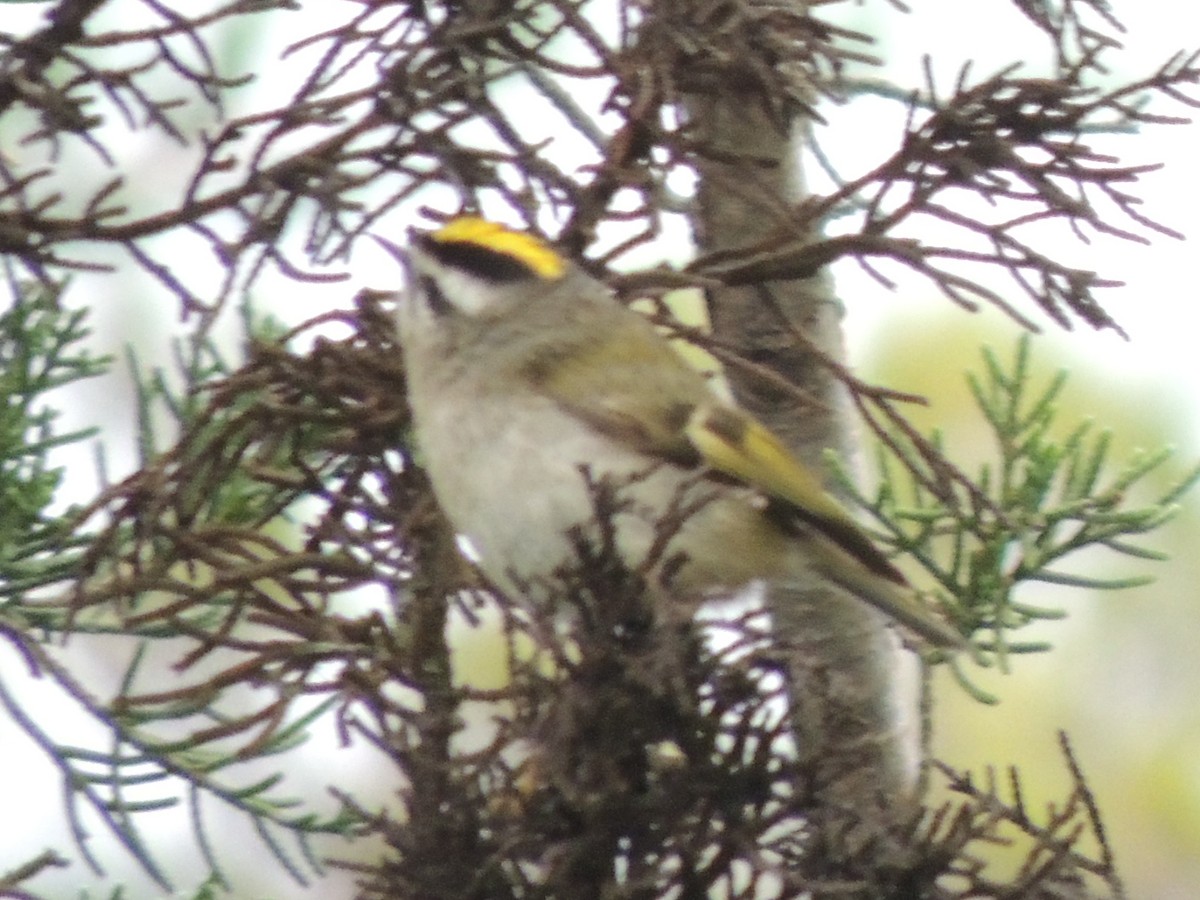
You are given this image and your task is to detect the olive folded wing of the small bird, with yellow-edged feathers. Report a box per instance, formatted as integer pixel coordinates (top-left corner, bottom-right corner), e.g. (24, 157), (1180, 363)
(524, 323), (905, 584)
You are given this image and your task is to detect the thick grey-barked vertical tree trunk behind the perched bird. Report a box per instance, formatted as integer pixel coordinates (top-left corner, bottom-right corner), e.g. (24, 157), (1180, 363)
(689, 91), (920, 842)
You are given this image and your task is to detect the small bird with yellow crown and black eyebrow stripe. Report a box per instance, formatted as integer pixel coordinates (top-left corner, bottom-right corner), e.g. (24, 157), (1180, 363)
(380, 217), (964, 646)
